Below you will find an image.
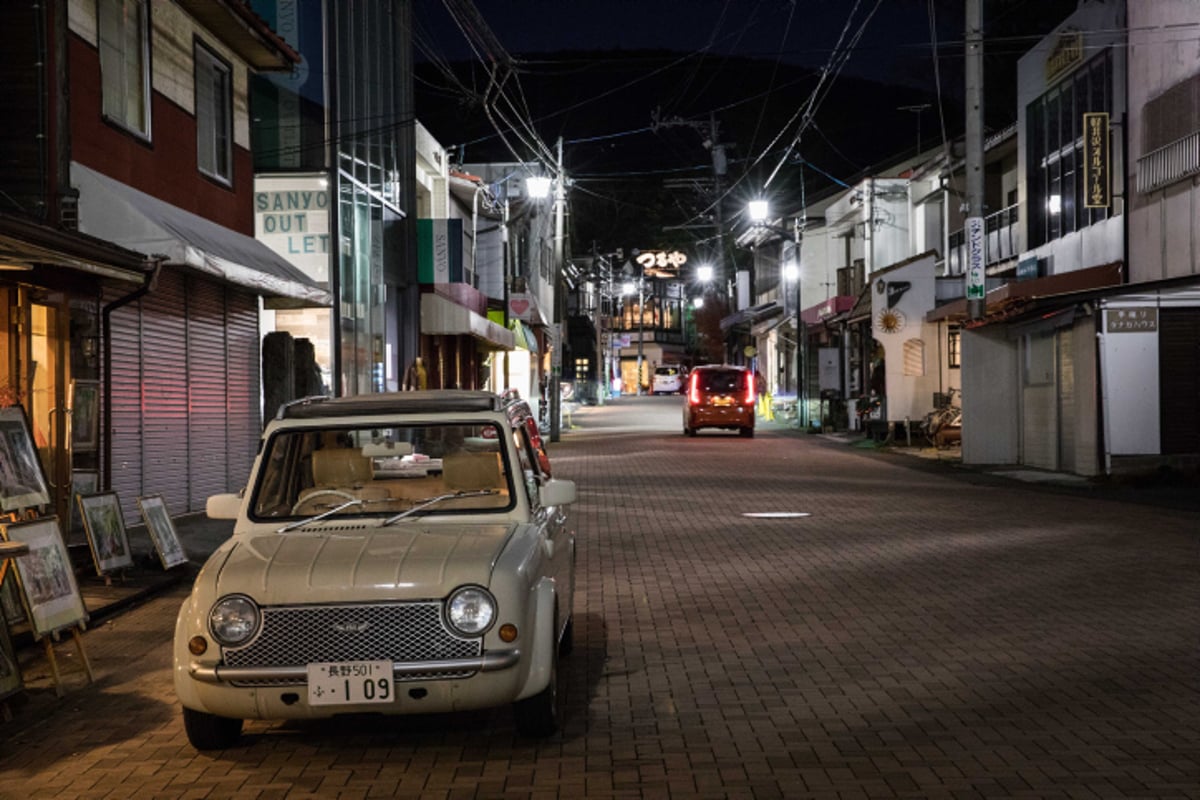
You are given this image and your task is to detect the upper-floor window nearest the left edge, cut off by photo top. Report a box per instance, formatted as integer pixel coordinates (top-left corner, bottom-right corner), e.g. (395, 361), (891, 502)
(96, 0), (150, 138)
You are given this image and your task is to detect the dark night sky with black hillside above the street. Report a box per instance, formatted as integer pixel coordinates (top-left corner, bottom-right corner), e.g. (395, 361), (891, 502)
(414, 0), (1076, 250)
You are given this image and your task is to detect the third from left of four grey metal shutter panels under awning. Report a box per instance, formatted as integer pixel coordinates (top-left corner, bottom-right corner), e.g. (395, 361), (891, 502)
(179, 278), (229, 511)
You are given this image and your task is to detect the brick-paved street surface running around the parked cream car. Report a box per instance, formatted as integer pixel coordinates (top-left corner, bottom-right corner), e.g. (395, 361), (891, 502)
(0, 397), (1200, 800)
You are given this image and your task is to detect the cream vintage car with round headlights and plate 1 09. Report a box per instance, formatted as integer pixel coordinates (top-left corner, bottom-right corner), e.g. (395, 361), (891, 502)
(174, 391), (575, 750)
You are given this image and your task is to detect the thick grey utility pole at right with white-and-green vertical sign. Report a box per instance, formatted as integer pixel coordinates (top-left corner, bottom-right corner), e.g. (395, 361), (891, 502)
(964, 0), (986, 319)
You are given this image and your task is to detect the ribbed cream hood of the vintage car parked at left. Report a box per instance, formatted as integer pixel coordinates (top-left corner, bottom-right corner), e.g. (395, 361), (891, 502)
(205, 524), (515, 606)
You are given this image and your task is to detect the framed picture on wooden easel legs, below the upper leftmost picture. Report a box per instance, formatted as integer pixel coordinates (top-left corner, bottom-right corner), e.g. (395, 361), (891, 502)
(4, 517), (88, 638)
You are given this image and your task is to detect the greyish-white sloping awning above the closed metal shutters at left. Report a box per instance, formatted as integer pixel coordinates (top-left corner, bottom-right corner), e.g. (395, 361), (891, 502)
(71, 163), (332, 307)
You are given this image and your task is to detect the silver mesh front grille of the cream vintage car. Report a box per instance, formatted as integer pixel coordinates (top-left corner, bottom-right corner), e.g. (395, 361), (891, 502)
(224, 601), (482, 686)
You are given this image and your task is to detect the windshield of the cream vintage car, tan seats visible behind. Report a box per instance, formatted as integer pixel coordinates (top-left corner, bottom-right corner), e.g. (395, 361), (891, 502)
(251, 423), (514, 519)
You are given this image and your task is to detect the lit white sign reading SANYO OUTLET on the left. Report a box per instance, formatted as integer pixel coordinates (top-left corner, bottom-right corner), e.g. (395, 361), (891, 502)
(254, 175), (330, 283)
